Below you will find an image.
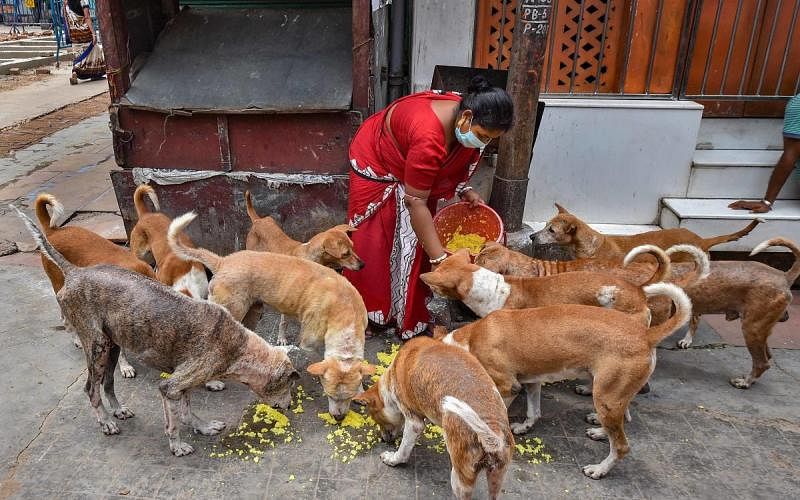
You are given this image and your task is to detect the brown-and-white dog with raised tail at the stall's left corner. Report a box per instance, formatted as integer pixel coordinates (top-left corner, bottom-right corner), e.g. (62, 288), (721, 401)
(130, 184), (208, 300)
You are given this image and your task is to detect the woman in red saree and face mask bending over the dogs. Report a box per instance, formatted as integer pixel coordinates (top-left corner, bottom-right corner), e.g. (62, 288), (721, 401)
(345, 76), (513, 339)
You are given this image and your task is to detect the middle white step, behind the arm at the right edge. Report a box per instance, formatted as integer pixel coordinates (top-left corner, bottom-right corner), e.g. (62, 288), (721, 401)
(686, 149), (800, 200)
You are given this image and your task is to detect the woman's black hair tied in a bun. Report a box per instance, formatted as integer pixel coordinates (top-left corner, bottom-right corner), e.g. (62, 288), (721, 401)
(458, 75), (514, 132)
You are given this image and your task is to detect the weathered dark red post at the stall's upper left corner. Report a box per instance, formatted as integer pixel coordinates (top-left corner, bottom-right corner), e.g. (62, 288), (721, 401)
(97, 0), (131, 103)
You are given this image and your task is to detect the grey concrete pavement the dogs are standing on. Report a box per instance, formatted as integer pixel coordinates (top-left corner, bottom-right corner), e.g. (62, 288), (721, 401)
(0, 78), (800, 499)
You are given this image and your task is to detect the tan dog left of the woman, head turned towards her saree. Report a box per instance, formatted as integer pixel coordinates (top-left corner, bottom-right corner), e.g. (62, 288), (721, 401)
(244, 191), (364, 271)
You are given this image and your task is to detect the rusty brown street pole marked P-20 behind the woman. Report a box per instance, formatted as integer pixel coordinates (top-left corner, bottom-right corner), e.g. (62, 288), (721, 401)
(489, 0), (553, 232)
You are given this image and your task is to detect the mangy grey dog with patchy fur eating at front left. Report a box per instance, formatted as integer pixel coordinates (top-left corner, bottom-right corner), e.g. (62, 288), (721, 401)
(12, 207), (299, 456)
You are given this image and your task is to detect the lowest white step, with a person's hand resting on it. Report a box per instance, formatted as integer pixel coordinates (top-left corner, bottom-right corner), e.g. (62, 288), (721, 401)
(660, 198), (800, 252)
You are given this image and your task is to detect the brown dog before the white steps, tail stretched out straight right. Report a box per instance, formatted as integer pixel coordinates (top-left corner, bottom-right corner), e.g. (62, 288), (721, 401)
(531, 203), (762, 259)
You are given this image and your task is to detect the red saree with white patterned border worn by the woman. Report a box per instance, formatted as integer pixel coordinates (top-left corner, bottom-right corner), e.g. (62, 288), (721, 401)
(345, 91), (480, 339)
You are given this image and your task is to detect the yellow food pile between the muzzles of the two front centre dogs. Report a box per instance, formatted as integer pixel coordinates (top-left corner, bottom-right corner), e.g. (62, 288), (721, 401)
(317, 410), (381, 464)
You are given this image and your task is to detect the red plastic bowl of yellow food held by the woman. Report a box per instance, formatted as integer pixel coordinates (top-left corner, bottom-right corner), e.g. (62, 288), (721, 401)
(433, 201), (504, 254)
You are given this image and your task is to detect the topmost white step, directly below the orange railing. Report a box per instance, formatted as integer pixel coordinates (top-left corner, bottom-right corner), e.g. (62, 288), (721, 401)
(697, 118), (783, 150)
